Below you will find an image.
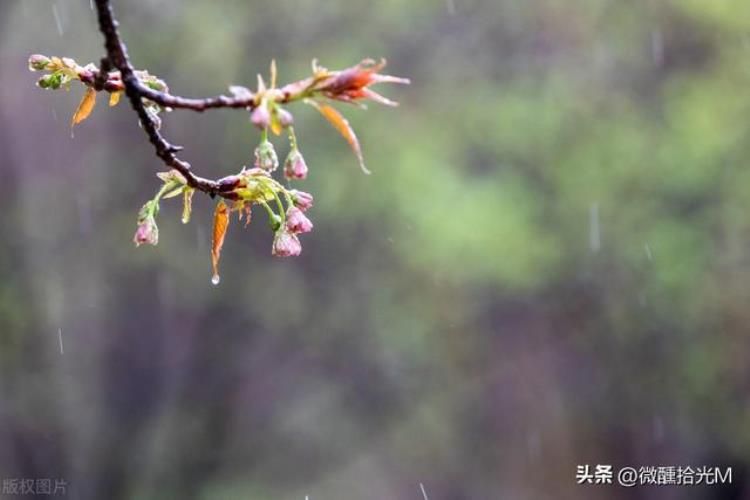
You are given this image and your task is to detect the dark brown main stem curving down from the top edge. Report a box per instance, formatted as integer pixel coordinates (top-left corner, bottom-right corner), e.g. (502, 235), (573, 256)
(93, 0), (220, 196)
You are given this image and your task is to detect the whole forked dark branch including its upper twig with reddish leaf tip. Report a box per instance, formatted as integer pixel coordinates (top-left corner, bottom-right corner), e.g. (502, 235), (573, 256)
(83, 0), (409, 199)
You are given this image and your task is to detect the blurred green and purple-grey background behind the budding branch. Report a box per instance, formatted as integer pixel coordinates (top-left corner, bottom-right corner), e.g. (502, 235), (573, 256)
(0, 0), (750, 500)
